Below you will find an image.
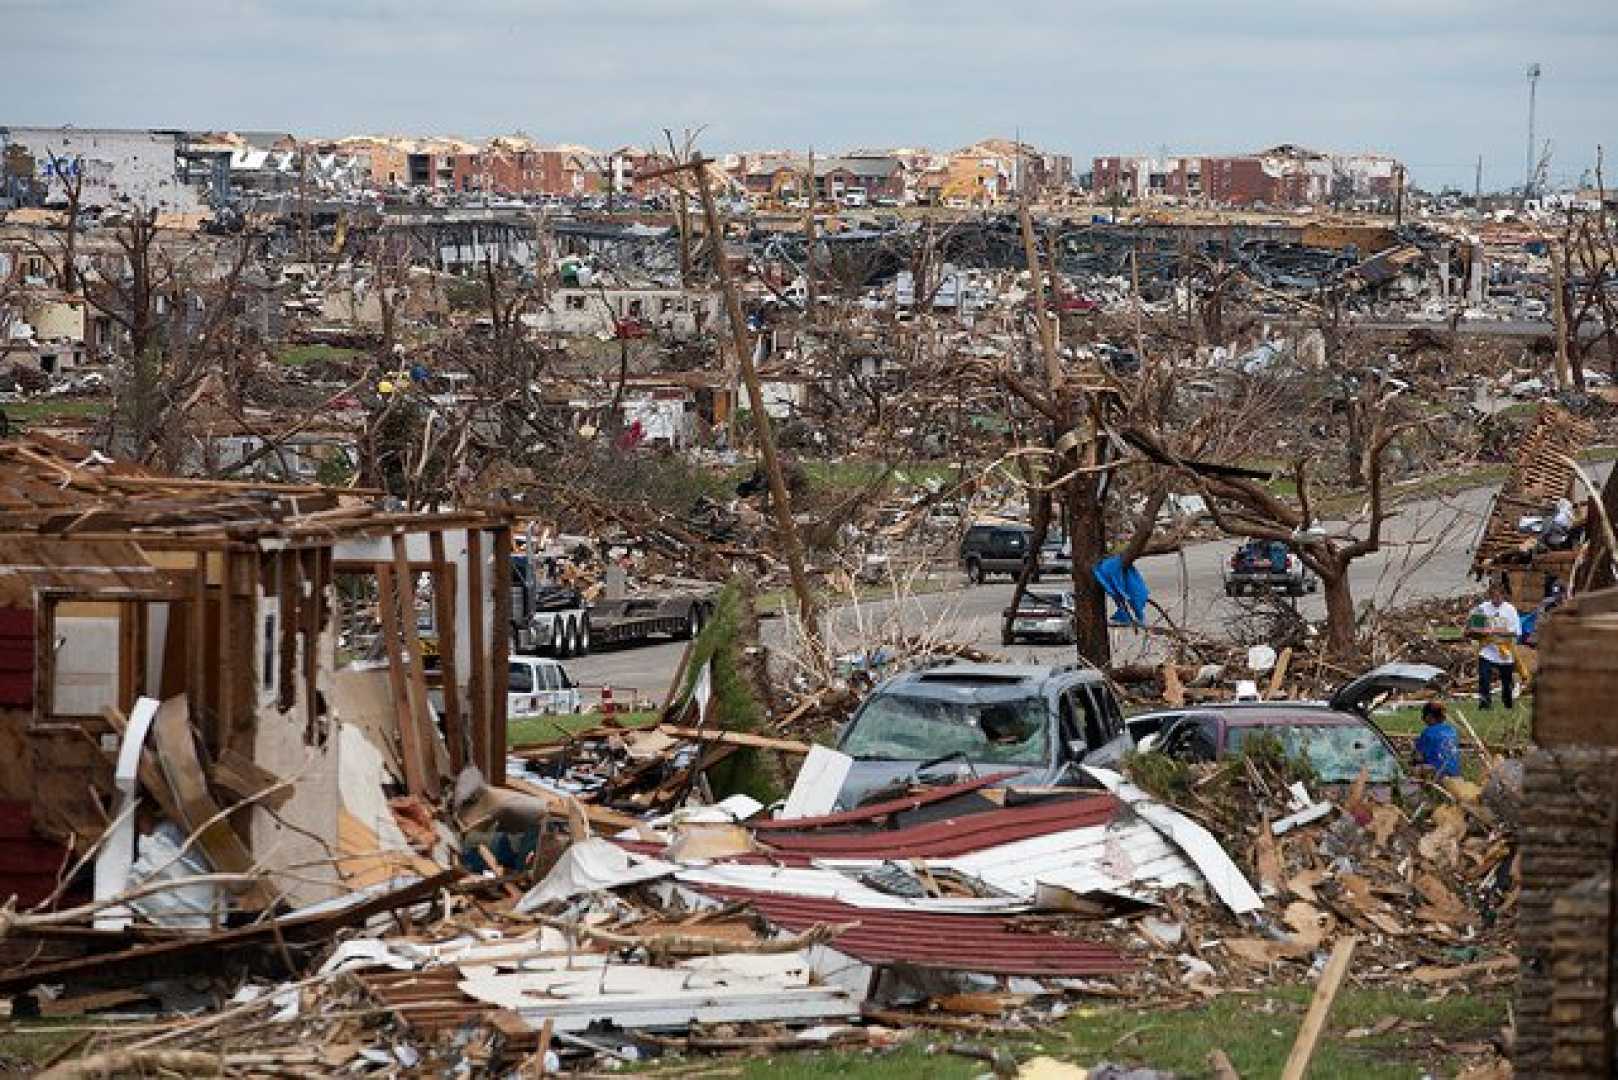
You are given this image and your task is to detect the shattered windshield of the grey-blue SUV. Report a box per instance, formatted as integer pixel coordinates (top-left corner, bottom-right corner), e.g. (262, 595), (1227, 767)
(841, 693), (1048, 764)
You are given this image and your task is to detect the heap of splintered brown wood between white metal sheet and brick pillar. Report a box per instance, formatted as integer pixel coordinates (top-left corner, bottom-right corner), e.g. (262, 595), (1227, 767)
(1129, 742), (1523, 993)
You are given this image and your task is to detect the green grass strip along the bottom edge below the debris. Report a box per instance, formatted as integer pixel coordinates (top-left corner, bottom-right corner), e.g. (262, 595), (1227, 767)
(718, 986), (1508, 1080)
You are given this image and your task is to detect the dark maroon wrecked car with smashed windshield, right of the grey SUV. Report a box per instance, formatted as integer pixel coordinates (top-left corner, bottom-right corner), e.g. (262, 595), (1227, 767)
(1128, 664), (1443, 784)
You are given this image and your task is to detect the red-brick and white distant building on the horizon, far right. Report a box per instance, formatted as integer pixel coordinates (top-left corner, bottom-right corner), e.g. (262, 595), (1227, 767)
(1092, 144), (1401, 207)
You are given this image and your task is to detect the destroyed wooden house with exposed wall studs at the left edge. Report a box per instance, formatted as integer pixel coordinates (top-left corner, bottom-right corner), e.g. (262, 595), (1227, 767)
(0, 437), (511, 913)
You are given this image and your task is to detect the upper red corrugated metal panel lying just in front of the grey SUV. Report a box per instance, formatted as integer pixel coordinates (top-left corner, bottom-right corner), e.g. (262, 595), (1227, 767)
(760, 795), (1118, 858)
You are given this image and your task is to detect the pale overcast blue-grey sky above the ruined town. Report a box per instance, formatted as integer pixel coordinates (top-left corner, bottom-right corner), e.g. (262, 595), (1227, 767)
(0, 0), (1618, 189)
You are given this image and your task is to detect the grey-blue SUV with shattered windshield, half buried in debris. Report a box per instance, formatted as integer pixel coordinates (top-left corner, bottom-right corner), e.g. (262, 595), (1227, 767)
(838, 664), (1131, 810)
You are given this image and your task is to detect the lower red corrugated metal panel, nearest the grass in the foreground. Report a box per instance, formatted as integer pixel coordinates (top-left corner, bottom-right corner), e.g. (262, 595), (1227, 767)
(699, 886), (1134, 978)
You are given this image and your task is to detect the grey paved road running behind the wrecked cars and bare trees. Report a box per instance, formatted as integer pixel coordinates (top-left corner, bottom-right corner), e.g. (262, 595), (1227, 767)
(568, 466), (1610, 701)
